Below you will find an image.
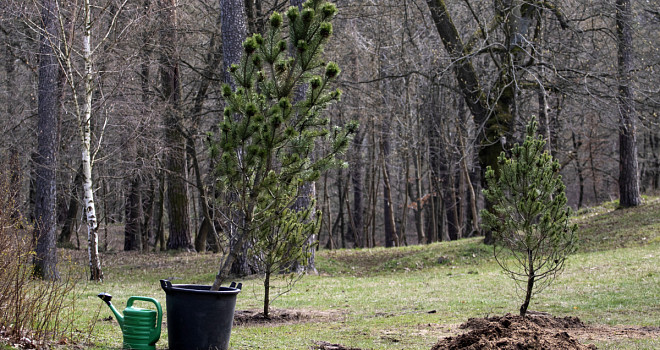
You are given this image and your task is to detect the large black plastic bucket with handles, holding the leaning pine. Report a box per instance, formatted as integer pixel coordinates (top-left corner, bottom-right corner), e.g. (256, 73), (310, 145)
(160, 280), (241, 350)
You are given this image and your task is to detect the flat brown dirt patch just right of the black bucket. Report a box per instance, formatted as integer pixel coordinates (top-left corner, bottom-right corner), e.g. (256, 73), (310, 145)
(234, 309), (339, 326)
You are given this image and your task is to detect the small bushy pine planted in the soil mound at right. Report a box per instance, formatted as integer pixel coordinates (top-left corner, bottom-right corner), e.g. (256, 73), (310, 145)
(482, 118), (577, 316)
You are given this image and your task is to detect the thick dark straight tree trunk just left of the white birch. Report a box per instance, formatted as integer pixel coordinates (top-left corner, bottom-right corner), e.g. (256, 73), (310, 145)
(34, 0), (62, 280)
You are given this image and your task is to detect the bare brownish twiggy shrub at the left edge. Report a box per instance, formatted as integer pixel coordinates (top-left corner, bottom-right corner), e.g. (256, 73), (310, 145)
(0, 164), (80, 348)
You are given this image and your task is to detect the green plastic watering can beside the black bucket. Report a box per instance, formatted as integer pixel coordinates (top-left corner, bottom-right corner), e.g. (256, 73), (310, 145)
(98, 293), (163, 350)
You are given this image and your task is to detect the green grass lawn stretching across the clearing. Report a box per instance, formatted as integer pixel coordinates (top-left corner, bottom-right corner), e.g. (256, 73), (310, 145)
(47, 198), (660, 349)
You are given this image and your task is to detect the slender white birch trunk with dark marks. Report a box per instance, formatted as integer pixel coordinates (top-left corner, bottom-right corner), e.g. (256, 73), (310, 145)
(80, 0), (103, 282)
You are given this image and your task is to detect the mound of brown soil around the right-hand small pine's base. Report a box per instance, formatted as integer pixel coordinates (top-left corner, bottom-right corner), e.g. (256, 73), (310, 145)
(431, 313), (596, 350)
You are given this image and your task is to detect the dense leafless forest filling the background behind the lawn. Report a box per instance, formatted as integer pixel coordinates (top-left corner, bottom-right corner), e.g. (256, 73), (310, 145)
(0, 0), (660, 278)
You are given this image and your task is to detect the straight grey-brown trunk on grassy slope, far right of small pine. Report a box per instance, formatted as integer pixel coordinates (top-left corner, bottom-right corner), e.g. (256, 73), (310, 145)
(616, 0), (642, 208)
